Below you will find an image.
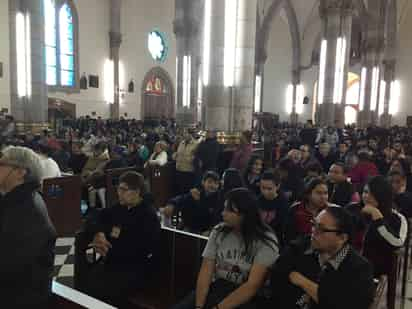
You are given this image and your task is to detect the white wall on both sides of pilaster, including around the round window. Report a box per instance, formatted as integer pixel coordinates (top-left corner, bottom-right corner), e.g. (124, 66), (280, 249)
(49, 0), (176, 119)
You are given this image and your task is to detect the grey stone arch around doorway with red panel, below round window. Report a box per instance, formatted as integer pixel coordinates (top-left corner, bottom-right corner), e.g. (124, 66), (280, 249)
(141, 66), (175, 119)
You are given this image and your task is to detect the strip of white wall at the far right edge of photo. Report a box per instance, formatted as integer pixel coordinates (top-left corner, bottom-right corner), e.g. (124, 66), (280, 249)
(392, 5), (412, 126)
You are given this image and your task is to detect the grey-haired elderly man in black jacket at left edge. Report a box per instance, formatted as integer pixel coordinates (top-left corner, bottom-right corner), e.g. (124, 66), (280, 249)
(0, 147), (56, 308)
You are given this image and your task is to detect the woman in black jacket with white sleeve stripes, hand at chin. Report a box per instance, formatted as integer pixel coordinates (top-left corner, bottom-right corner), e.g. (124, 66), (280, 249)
(346, 176), (408, 276)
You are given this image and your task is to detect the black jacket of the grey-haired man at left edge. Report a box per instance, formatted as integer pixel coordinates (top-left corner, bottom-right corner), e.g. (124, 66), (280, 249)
(0, 183), (56, 308)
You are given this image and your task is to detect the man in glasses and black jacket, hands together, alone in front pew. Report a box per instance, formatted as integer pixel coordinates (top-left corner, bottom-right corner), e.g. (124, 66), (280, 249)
(86, 172), (160, 307)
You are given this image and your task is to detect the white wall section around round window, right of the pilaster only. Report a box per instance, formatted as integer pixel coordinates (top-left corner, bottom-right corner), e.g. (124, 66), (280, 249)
(120, 0), (176, 119)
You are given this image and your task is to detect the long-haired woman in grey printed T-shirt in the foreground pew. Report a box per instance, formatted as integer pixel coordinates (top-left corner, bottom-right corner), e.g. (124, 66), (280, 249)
(173, 188), (279, 309)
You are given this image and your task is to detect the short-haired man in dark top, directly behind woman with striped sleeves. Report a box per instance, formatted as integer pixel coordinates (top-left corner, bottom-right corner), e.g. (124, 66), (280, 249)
(328, 162), (360, 206)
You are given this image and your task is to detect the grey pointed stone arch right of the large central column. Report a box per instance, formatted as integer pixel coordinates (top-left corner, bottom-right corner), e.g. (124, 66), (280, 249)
(256, 0), (301, 71)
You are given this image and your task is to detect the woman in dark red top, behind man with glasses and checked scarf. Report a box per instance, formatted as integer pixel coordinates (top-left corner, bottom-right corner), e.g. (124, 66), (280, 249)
(284, 178), (332, 244)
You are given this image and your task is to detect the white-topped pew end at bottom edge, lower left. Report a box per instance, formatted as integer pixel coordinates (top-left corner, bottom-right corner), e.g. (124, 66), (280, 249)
(49, 281), (115, 309)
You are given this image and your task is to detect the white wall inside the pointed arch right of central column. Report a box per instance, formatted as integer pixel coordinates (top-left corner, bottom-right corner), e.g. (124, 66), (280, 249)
(263, 16), (292, 121)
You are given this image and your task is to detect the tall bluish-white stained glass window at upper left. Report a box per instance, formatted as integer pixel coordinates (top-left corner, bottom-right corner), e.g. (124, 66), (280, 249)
(44, 0), (76, 88)
